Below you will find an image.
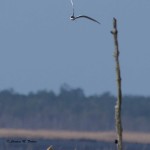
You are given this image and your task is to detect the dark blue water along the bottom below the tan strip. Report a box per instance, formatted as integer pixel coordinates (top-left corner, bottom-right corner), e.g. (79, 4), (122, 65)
(0, 138), (150, 150)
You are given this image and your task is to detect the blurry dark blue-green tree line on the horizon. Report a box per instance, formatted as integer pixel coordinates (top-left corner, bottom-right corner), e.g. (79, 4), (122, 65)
(0, 86), (150, 132)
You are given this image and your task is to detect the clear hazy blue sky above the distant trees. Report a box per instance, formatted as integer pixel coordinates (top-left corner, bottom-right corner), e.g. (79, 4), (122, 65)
(0, 0), (150, 95)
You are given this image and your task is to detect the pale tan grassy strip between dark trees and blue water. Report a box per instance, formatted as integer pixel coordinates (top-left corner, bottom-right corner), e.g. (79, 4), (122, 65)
(0, 129), (150, 144)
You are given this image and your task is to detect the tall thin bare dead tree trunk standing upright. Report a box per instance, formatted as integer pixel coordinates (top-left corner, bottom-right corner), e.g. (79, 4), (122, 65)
(111, 18), (122, 150)
